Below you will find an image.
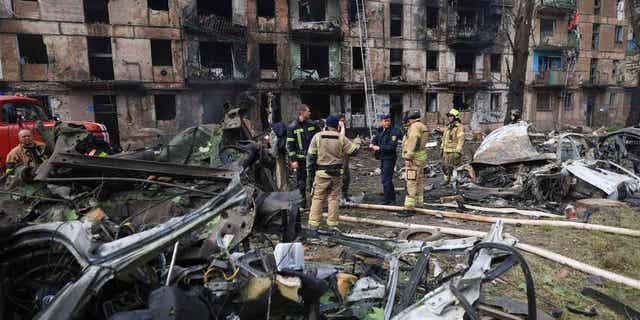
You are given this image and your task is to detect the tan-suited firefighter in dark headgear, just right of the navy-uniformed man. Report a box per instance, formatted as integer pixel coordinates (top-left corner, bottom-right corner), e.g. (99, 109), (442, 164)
(402, 109), (429, 210)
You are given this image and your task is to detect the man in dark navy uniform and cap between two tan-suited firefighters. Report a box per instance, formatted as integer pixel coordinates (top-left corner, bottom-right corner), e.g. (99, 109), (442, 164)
(369, 114), (402, 205)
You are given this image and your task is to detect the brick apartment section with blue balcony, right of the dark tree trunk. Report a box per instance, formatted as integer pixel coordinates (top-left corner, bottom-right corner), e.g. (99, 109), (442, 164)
(524, 0), (640, 129)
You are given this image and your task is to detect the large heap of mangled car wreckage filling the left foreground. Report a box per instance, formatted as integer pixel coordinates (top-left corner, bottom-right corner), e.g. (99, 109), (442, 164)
(0, 110), (552, 320)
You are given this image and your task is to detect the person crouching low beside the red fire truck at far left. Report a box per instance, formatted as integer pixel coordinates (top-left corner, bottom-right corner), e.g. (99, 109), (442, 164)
(5, 129), (46, 175)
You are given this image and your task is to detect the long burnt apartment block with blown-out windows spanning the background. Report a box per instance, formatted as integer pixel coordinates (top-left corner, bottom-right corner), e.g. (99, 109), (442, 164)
(0, 0), (632, 149)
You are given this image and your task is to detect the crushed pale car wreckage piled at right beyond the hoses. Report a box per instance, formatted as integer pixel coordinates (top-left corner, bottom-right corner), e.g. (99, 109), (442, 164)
(454, 122), (640, 212)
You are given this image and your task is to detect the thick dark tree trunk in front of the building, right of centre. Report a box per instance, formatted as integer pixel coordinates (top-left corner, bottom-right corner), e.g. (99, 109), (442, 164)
(504, 0), (536, 124)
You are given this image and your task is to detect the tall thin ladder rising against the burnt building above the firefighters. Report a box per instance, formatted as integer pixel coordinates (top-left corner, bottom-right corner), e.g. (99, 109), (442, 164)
(355, 0), (376, 137)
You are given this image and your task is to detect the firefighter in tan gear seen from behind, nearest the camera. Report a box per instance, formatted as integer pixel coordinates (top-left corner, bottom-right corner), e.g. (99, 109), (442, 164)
(307, 115), (359, 228)
